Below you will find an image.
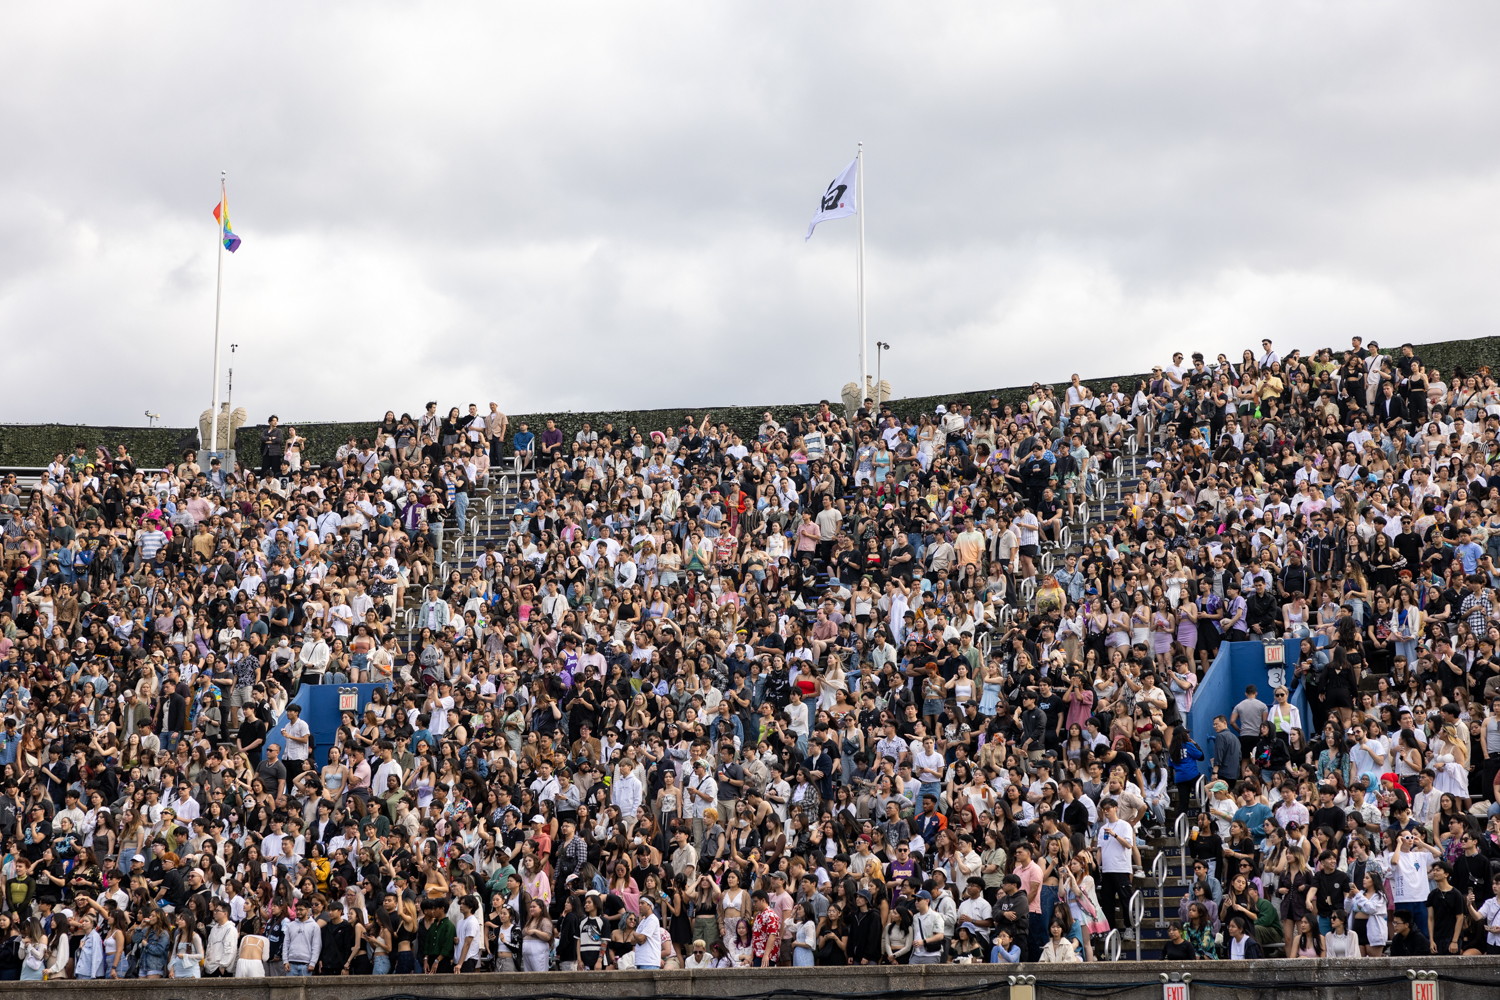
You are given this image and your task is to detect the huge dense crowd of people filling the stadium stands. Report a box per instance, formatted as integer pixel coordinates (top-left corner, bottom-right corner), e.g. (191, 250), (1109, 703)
(0, 337), (1500, 981)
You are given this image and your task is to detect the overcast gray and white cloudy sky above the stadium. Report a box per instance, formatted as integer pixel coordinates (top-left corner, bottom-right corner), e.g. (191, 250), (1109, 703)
(0, 1), (1500, 424)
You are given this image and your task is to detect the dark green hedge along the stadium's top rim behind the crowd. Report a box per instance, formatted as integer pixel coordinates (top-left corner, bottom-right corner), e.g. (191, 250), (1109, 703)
(11, 337), (1500, 466)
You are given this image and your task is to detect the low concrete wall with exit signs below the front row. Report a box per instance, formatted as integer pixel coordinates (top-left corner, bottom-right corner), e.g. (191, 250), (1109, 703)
(0, 957), (1500, 1000)
